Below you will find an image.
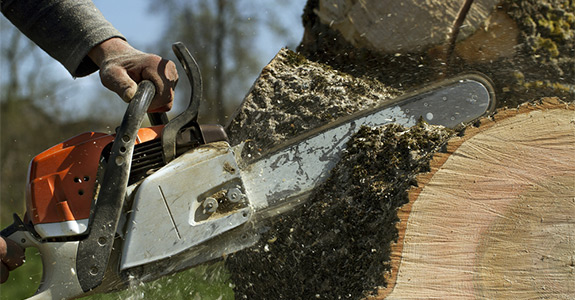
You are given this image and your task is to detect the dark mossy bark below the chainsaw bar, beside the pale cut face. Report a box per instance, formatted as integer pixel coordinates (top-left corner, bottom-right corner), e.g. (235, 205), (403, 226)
(226, 123), (452, 299)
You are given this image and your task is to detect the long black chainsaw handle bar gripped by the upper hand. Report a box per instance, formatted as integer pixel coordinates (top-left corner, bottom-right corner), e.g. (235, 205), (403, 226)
(76, 80), (156, 292)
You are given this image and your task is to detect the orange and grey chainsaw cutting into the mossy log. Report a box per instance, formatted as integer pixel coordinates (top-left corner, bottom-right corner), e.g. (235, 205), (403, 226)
(1, 43), (495, 299)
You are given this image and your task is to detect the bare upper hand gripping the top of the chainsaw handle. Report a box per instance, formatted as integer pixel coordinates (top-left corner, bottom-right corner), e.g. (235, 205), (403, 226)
(88, 38), (178, 112)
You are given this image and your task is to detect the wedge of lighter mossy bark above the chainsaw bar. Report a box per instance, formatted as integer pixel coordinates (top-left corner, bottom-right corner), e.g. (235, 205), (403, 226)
(226, 49), (400, 158)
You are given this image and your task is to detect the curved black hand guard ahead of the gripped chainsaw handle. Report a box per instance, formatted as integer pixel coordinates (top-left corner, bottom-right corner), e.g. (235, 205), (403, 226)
(162, 42), (204, 164)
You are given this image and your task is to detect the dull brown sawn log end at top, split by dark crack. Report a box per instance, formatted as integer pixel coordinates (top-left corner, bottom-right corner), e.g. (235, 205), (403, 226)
(315, 0), (500, 54)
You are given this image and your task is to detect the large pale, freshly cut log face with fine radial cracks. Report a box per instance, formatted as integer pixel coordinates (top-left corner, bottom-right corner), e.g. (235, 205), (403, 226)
(378, 100), (575, 299)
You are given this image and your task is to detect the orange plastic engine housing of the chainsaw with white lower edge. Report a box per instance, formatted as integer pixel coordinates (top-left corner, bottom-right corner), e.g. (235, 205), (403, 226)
(26, 125), (164, 238)
